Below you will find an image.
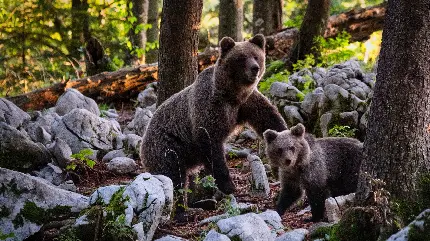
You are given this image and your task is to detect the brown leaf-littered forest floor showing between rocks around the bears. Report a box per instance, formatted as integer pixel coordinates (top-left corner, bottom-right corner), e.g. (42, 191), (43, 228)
(75, 108), (312, 240)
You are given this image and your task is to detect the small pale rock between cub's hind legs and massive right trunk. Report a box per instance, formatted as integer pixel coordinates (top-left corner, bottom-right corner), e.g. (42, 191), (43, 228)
(325, 193), (355, 223)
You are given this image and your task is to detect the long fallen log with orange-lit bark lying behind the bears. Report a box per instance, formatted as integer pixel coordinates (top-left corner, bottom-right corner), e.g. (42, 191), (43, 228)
(7, 4), (385, 110)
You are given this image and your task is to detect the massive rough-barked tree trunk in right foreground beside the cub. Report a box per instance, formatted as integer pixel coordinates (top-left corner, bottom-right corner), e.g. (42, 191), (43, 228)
(357, 0), (430, 205)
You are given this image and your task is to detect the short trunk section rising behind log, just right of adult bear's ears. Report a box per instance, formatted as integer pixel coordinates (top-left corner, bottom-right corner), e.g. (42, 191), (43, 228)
(252, 0), (283, 35)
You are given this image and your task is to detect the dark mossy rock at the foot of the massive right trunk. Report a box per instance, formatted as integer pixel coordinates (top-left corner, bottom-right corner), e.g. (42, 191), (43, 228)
(336, 207), (380, 241)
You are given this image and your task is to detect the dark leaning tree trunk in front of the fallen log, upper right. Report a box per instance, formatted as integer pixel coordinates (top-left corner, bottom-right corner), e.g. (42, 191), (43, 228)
(287, 0), (330, 69)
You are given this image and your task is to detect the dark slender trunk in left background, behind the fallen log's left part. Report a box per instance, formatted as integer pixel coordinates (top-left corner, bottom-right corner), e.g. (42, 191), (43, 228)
(68, 0), (91, 61)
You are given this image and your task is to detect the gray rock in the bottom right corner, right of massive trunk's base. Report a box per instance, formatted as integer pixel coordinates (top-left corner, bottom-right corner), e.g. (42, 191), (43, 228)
(387, 209), (430, 241)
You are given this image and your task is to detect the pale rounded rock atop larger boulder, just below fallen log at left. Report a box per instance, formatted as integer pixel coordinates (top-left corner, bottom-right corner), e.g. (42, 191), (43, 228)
(55, 88), (100, 116)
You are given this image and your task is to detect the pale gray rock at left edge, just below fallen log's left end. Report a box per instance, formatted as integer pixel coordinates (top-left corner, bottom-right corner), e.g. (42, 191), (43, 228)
(0, 98), (30, 128)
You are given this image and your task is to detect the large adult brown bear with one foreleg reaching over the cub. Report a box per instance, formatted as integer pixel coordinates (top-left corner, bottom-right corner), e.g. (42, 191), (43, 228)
(140, 34), (287, 207)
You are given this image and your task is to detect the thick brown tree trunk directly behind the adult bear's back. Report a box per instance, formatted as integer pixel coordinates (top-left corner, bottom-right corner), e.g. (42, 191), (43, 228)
(157, 0), (203, 106)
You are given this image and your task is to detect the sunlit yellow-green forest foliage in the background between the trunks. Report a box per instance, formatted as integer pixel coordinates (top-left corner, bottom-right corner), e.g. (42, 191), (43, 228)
(0, 0), (382, 96)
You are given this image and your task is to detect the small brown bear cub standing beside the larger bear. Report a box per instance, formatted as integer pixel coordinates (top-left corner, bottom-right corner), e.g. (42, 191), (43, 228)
(263, 124), (363, 221)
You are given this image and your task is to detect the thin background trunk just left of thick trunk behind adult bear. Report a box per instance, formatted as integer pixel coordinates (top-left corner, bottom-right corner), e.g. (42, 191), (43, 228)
(145, 0), (160, 63)
